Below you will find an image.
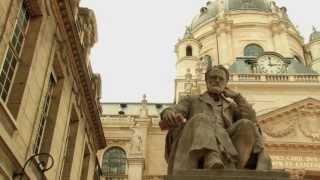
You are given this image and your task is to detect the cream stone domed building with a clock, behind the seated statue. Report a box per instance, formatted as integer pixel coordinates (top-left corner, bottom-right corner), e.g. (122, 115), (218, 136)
(99, 0), (320, 180)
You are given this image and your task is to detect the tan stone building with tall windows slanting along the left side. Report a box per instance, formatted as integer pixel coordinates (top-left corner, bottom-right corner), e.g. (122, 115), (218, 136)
(0, 0), (106, 180)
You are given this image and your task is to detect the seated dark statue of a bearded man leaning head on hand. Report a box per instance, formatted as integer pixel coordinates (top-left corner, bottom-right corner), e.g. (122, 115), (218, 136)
(159, 65), (271, 174)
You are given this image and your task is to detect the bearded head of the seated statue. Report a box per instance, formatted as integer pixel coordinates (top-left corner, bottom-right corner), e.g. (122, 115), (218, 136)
(205, 65), (229, 94)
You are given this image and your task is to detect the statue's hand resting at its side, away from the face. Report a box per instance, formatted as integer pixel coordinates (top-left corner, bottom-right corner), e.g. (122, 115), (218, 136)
(159, 110), (185, 129)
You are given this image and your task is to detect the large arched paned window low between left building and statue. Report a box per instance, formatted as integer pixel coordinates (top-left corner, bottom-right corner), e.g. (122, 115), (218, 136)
(102, 147), (127, 176)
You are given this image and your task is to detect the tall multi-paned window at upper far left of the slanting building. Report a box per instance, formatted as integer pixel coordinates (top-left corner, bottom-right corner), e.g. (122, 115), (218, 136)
(0, 3), (30, 102)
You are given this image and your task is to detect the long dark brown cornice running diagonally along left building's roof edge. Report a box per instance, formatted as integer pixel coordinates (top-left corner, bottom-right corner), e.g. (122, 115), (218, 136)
(56, 0), (106, 148)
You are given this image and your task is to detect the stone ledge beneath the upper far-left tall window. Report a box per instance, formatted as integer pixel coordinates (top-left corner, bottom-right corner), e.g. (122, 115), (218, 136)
(0, 99), (17, 133)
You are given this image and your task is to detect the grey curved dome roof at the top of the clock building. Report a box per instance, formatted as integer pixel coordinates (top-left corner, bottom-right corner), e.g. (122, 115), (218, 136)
(191, 0), (271, 29)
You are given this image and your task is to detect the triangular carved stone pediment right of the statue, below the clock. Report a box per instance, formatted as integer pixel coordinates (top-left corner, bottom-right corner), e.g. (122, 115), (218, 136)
(257, 98), (320, 143)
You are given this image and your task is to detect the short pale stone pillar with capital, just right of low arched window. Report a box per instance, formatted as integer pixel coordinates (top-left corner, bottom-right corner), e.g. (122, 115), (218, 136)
(128, 157), (144, 180)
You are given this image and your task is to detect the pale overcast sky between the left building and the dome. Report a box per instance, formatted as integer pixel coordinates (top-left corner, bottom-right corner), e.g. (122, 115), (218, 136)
(80, 0), (320, 102)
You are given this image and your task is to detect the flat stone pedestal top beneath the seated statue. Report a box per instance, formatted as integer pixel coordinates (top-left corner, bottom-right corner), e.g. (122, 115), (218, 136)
(165, 170), (294, 180)
